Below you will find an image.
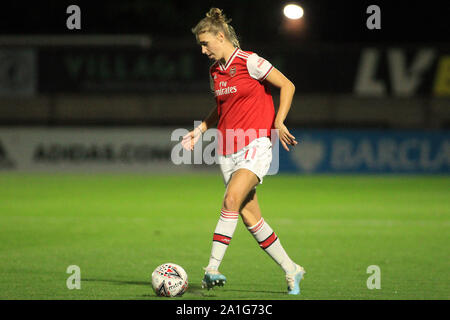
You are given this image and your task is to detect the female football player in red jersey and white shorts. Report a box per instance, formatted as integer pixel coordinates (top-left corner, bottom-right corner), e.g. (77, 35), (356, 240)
(182, 8), (305, 294)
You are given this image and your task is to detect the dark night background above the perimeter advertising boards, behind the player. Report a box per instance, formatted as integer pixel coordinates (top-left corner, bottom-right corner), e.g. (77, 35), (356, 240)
(0, 0), (450, 129)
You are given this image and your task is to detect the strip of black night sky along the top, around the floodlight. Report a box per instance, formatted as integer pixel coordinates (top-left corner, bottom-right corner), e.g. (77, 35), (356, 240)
(0, 0), (450, 43)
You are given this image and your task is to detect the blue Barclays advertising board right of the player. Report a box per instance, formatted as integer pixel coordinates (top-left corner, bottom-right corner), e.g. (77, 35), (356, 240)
(279, 130), (450, 174)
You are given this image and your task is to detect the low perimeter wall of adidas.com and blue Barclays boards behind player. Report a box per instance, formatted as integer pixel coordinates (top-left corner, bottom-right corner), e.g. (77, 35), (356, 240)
(0, 128), (450, 174)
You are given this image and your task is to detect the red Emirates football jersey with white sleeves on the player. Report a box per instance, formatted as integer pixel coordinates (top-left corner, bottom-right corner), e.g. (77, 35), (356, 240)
(210, 48), (275, 155)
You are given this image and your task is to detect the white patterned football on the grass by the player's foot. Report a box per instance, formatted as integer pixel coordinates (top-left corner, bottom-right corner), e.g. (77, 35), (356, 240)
(152, 263), (188, 297)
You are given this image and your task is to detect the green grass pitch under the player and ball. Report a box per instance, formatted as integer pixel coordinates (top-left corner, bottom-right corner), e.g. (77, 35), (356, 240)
(0, 172), (450, 300)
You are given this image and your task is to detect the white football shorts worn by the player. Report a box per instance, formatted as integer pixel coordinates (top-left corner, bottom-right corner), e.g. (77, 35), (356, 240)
(219, 137), (272, 186)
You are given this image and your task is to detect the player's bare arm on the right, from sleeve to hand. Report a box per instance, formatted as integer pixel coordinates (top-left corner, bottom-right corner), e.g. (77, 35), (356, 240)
(265, 68), (298, 151)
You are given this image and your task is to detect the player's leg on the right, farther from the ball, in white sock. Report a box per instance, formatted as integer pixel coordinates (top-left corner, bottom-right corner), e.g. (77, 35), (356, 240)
(241, 189), (305, 294)
